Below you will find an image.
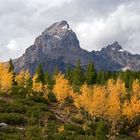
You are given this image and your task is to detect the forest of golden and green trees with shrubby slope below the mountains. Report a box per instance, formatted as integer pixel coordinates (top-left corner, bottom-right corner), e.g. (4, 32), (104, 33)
(0, 60), (140, 140)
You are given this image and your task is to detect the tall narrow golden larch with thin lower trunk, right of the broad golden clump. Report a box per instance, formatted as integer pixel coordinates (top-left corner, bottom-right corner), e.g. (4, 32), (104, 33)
(106, 80), (123, 135)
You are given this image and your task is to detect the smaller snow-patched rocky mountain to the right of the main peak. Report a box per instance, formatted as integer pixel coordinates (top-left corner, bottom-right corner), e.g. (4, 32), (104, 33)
(91, 41), (140, 71)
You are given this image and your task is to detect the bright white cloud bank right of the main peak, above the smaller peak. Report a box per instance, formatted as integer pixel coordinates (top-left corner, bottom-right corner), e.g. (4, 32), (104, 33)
(75, 3), (140, 53)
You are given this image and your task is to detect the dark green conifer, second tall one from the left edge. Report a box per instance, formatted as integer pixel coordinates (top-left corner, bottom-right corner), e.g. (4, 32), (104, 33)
(36, 64), (44, 83)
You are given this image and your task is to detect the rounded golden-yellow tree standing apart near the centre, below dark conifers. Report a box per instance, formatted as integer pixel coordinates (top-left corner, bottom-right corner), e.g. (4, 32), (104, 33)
(53, 73), (73, 102)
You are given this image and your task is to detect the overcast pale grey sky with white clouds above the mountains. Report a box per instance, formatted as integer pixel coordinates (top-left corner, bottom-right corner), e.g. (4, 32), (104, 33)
(0, 0), (140, 61)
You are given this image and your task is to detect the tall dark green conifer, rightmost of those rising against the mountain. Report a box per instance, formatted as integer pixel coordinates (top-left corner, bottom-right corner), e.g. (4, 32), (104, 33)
(85, 63), (96, 85)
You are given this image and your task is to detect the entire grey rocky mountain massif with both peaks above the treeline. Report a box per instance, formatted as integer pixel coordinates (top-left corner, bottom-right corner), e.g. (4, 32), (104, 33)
(14, 21), (140, 74)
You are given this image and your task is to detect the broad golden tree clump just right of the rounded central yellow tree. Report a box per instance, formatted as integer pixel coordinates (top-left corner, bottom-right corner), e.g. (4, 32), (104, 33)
(74, 84), (107, 117)
